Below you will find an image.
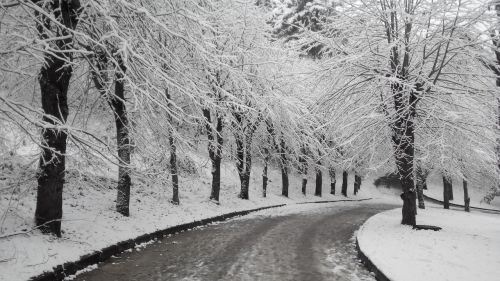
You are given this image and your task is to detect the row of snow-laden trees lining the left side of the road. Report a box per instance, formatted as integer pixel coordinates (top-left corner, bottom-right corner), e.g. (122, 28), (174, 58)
(0, 0), (364, 236)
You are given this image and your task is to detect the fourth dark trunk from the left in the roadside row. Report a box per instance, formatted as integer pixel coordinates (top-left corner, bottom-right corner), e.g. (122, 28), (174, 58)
(203, 108), (224, 203)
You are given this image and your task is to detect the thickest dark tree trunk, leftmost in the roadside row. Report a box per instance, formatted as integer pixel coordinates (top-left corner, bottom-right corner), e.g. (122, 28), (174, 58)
(35, 0), (80, 237)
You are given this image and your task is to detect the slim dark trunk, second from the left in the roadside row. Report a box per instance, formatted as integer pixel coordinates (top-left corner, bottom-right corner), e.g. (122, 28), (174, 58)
(109, 55), (131, 216)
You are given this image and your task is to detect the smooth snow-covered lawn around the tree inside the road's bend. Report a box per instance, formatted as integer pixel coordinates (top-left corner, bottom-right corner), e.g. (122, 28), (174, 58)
(357, 207), (500, 281)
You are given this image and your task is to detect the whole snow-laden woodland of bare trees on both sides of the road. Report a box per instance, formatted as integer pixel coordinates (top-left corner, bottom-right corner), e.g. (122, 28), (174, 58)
(0, 0), (500, 236)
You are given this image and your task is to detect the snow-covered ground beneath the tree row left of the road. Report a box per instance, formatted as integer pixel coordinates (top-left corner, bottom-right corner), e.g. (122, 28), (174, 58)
(0, 153), (373, 281)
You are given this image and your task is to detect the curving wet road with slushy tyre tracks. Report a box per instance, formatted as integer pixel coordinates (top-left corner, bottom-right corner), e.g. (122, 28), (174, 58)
(74, 201), (397, 281)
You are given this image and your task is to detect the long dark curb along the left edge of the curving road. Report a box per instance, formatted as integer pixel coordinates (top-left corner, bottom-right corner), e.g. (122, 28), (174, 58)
(29, 198), (371, 281)
